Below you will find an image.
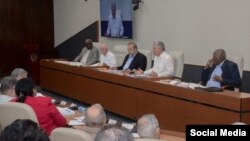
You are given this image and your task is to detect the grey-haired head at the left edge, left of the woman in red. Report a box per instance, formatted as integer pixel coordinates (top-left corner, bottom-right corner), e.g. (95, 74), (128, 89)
(0, 76), (17, 94)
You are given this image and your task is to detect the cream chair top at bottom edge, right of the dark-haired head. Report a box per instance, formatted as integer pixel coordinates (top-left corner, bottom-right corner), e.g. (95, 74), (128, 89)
(50, 127), (92, 141)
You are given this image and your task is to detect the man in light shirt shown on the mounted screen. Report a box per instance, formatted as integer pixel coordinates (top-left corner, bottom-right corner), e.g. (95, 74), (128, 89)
(106, 2), (124, 37)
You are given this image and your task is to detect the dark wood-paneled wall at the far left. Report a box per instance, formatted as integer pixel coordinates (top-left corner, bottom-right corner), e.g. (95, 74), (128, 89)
(0, 0), (54, 74)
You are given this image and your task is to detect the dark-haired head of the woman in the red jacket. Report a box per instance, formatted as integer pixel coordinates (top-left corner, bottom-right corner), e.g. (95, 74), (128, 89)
(15, 78), (36, 103)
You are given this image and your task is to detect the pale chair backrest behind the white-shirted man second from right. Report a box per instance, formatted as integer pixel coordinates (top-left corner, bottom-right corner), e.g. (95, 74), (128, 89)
(169, 51), (184, 78)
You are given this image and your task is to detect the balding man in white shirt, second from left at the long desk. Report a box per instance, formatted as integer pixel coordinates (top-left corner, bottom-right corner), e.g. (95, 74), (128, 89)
(94, 44), (117, 67)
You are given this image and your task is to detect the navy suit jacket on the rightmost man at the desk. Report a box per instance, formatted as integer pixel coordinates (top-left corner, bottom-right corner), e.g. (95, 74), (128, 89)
(201, 60), (241, 87)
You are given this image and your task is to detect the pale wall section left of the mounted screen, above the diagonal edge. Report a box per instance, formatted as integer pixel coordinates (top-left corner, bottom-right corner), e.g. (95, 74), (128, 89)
(54, 0), (100, 46)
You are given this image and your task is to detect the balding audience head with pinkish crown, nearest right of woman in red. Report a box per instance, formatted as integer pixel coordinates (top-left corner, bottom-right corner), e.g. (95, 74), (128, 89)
(84, 104), (106, 127)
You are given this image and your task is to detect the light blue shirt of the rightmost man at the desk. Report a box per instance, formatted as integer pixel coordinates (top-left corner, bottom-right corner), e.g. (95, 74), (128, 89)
(206, 61), (224, 88)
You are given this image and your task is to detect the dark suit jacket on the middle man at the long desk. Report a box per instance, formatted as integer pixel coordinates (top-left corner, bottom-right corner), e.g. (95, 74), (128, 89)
(117, 52), (147, 71)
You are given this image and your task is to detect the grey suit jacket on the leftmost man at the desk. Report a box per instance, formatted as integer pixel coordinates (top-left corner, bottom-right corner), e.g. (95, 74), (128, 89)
(74, 46), (99, 65)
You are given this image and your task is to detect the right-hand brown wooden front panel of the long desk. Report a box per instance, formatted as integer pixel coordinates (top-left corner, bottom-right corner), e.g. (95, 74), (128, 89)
(137, 92), (240, 132)
